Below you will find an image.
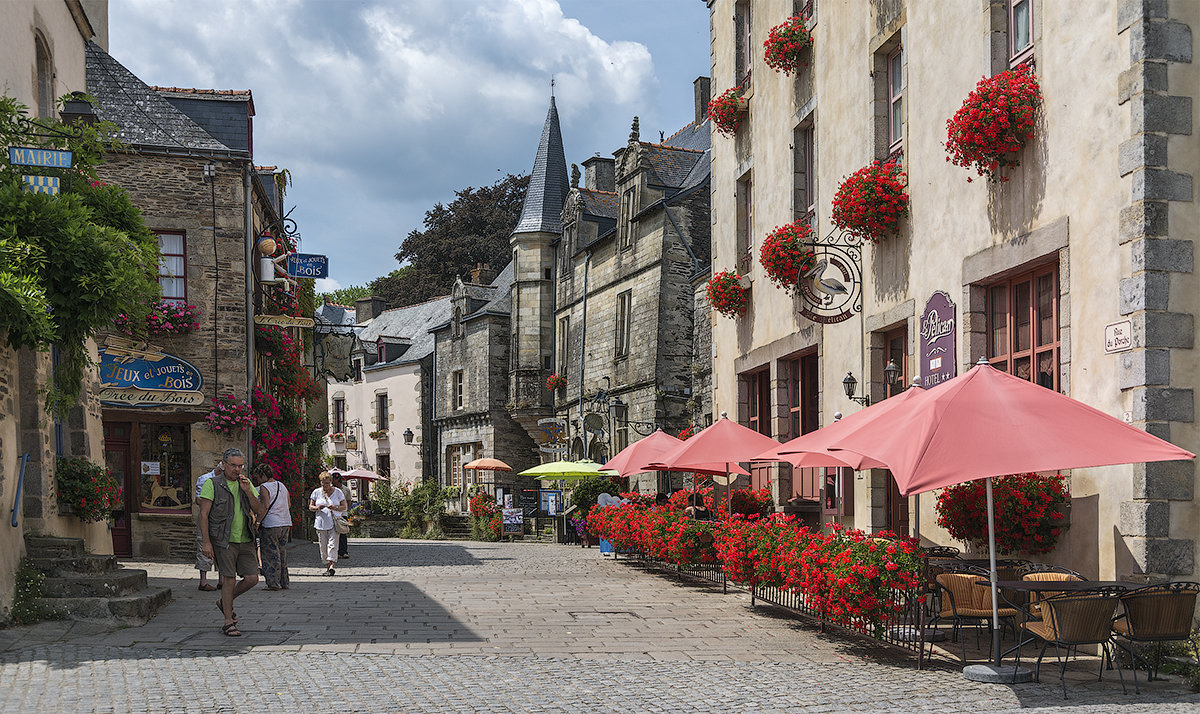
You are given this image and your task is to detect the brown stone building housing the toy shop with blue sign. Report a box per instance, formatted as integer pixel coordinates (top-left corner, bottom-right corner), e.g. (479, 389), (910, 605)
(86, 43), (288, 559)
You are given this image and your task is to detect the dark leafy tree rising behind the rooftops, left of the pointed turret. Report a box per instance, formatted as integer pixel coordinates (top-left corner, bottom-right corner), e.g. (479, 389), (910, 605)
(370, 174), (529, 307)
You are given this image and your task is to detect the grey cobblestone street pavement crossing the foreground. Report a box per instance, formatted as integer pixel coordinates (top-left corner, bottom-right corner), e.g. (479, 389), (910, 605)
(0, 540), (1200, 714)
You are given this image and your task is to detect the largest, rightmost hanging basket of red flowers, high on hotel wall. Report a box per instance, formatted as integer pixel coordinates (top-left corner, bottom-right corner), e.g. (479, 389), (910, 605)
(946, 65), (1042, 182)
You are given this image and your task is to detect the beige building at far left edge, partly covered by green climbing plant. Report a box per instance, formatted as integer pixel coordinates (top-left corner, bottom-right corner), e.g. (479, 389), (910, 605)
(0, 0), (113, 622)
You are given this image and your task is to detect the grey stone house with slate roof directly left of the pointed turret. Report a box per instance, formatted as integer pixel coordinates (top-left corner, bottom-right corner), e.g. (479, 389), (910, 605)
(430, 263), (538, 506)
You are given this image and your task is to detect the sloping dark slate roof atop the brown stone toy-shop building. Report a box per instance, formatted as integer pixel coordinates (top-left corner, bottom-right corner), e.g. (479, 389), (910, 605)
(86, 41), (234, 154)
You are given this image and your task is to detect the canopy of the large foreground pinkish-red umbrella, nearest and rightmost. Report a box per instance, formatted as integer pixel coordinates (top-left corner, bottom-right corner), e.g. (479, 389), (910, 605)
(822, 364), (1195, 496)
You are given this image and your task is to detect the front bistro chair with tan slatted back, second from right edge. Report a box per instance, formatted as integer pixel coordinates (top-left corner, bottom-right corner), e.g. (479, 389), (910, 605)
(1025, 588), (1126, 698)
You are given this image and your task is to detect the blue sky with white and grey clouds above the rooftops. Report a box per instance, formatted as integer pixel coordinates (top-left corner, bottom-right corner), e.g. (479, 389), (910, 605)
(109, 0), (709, 288)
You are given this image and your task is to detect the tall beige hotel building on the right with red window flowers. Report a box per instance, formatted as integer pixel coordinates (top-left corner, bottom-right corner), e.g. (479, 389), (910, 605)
(708, 0), (1200, 580)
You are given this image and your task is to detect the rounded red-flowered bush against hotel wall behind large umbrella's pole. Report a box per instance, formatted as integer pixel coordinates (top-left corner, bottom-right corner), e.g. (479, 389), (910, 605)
(937, 474), (1070, 553)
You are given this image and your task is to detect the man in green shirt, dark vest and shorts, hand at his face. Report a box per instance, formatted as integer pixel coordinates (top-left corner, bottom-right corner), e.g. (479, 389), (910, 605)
(199, 449), (265, 637)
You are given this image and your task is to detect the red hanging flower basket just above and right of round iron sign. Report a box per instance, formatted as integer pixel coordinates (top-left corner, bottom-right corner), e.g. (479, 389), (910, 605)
(833, 161), (908, 244)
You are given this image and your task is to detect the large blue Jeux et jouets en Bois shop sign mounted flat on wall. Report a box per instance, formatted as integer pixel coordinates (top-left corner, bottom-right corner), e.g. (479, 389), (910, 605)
(100, 346), (204, 407)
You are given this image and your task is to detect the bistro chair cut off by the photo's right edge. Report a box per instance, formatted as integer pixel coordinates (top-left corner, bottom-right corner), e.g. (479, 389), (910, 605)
(1112, 582), (1200, 692)
